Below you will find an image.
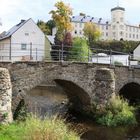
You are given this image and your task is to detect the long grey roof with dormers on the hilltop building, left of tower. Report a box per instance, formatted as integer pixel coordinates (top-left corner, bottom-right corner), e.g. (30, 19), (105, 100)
(71, 15), (110, 24)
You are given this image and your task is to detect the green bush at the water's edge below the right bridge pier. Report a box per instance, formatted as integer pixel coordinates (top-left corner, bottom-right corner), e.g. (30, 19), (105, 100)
(96, 96), (137, 126)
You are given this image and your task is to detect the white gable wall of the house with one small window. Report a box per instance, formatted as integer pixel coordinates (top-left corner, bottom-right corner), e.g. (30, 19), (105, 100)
(11, 19), (45, 61)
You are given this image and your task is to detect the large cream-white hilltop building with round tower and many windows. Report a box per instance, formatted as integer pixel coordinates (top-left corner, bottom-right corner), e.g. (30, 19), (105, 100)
(53, 6), (140, 41)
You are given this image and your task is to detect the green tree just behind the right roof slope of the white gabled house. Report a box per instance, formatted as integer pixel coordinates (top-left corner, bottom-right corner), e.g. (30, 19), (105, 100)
(37, 20), (51, 35)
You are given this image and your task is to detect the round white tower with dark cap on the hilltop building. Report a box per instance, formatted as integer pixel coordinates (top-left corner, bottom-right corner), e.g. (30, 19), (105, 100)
(111, 6), (125, 40)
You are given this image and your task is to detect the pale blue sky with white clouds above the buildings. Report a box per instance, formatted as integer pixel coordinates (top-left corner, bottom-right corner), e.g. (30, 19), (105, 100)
(0, 0), (140, 32)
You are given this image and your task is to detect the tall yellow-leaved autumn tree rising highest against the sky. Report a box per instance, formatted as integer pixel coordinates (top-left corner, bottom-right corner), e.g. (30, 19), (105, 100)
(50, 1), (72, 42)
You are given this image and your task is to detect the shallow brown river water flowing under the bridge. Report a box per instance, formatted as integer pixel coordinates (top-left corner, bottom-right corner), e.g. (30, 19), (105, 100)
(26, 87), (140, 140)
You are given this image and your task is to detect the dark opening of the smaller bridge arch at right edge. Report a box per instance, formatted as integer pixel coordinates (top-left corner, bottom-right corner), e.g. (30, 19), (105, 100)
(119, 82), (140, 103)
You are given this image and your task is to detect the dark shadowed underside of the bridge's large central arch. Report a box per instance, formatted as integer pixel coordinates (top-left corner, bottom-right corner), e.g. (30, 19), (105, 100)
(54, 79), (90, 111)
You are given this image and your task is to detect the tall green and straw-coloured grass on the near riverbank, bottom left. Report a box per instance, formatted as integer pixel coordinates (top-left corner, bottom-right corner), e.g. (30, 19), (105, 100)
(0, 116), (80, 140)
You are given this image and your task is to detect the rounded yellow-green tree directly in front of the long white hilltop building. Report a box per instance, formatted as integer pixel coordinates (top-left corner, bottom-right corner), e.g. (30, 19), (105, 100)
(83, 22), (101, 46)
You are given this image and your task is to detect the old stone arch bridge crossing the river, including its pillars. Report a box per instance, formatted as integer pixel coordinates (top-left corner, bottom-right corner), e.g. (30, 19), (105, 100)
(0, 62), (140, 121)
